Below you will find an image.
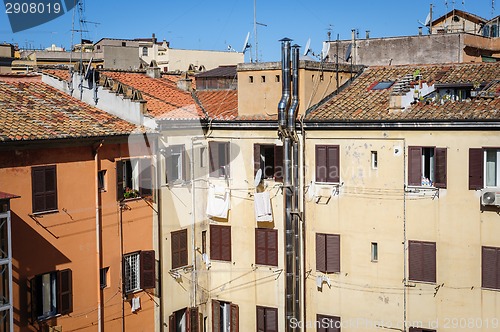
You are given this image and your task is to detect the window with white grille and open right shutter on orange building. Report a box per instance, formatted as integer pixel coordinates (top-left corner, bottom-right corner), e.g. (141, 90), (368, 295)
(123, 250), (156, 294)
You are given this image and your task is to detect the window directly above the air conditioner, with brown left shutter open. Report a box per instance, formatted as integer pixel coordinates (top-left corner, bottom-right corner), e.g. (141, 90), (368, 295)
(469, 148), (500, 190)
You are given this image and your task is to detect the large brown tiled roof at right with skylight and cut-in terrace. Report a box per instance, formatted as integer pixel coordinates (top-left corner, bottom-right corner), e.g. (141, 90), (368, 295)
(306, 63), (500, 122)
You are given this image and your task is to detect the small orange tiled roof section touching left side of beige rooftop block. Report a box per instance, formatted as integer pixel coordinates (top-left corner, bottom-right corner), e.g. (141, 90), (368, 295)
(196, 90), (238, 120)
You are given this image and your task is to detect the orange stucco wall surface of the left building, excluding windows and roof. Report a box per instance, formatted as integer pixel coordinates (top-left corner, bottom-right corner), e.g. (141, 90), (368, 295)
(0, 144), (155, 331)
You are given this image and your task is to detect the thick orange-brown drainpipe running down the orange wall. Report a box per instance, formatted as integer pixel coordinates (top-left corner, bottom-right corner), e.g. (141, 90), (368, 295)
(93, 140), (104, 332)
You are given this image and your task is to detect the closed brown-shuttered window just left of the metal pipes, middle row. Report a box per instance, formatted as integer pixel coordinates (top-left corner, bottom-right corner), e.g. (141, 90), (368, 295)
(255, 228), (278, 266)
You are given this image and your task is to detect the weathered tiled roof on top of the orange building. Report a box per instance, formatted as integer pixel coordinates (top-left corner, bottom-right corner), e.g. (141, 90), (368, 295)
(0, 75), (143, 142)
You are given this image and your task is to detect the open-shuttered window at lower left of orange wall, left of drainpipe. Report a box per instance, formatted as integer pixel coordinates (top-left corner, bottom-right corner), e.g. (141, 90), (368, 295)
(30, 269), (73, 321)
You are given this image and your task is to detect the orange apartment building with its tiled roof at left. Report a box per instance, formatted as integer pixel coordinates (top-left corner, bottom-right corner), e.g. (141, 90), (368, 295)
(0, 75), (159, 331)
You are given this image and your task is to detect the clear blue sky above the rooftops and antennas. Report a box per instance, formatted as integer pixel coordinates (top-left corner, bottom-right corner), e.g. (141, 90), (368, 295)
(0, 0), (500, 61)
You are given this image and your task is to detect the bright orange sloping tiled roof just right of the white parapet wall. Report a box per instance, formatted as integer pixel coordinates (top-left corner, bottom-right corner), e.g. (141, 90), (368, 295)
(101, 71), (205, 120)
